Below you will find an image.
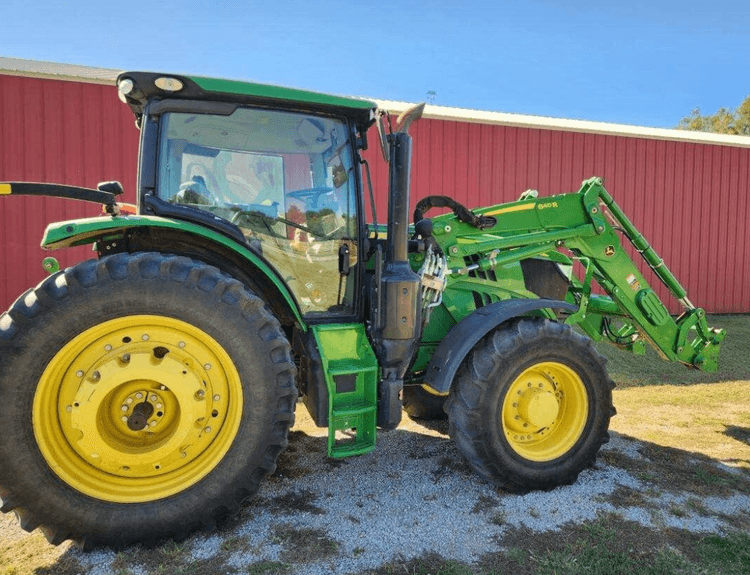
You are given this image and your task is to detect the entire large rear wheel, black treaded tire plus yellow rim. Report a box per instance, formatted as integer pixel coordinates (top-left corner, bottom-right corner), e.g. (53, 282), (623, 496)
(0, 253), (297, 548)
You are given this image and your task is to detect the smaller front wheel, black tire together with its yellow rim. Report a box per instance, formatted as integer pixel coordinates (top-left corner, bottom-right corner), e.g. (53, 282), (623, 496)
(446, 318), (615, 491)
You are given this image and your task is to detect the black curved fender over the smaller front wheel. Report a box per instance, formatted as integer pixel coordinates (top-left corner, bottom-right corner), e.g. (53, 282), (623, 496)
(424, 299), (578, 393)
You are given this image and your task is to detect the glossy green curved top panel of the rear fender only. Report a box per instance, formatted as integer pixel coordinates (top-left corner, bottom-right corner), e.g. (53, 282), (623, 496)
(41, 216), (307, 329)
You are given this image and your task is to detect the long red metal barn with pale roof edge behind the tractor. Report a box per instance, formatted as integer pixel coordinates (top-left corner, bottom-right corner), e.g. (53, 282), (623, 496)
(0, 58), (750, 313)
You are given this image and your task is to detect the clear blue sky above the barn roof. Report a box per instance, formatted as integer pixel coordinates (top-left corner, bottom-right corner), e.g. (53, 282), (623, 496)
(0, 0), (750, 127)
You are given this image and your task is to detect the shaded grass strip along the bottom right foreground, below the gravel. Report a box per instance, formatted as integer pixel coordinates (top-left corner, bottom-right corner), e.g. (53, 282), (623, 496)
(374, 516), (750, 575)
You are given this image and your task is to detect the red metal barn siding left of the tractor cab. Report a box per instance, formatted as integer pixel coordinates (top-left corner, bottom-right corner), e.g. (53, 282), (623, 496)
(0, 75), (138, 309)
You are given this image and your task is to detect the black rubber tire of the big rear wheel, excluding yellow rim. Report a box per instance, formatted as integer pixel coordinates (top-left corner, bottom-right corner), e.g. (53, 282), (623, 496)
(0, 253), (296, 547)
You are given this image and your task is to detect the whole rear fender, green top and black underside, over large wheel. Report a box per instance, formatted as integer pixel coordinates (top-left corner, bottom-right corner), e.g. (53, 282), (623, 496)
(42, 216), (307, 330)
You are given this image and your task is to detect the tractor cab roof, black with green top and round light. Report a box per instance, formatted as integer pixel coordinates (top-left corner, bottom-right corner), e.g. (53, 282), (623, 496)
(117, 72), (377, 125)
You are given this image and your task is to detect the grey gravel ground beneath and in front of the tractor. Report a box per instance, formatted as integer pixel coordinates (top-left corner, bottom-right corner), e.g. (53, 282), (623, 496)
(2, 409), (750, 575)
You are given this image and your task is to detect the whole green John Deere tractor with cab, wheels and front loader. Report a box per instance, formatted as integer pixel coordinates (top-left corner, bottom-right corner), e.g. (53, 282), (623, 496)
(0, 72), (724, 548)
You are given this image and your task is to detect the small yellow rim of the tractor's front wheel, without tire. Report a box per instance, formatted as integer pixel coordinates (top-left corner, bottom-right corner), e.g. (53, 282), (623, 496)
(501, 362), (589, 461)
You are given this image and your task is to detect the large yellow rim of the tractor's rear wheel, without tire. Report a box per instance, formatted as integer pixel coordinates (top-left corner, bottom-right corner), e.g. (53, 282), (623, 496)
(32, 315), (243, 503)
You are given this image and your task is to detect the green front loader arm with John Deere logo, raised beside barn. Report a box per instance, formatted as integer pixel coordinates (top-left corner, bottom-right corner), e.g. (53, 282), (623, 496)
(435, 178), (725, 372)
